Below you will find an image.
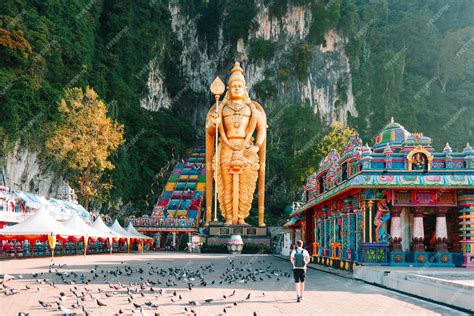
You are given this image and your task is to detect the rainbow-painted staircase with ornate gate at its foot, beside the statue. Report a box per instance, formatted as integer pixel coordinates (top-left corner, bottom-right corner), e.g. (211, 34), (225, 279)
(128, 147), (206, 248)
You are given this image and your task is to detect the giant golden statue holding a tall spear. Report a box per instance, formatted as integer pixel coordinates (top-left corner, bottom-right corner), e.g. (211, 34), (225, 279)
(206, 63), (267, 226)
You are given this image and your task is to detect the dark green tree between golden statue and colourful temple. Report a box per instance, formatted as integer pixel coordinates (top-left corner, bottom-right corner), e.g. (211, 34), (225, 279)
(265, 104), (321, 218)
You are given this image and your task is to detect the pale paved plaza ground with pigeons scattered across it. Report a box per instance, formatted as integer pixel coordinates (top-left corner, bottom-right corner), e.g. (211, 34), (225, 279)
(0, 253), (462, 315)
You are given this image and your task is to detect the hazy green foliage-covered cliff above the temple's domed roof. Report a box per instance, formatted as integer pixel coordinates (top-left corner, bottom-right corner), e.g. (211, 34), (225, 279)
(338, 0), (474, 150)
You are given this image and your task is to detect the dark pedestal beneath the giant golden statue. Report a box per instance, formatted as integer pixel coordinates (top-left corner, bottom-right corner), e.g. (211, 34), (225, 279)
(203, 222), (270, 254)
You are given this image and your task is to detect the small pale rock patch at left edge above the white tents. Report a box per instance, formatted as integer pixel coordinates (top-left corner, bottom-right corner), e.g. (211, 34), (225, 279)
(3, 142), (62, 197)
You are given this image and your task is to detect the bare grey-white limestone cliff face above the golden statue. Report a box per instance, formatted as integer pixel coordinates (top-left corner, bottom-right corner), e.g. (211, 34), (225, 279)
(141, 2), (357, 125)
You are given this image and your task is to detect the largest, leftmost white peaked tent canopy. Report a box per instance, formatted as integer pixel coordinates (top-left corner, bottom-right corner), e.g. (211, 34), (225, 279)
(0, 207), (83, 237)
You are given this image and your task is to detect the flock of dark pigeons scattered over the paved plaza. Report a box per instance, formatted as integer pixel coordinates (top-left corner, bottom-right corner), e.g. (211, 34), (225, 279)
(0, 257), (290, 316)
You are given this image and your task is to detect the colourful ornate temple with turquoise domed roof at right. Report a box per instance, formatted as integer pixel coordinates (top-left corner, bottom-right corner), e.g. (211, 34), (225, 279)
(285, 119), (474, 270)
